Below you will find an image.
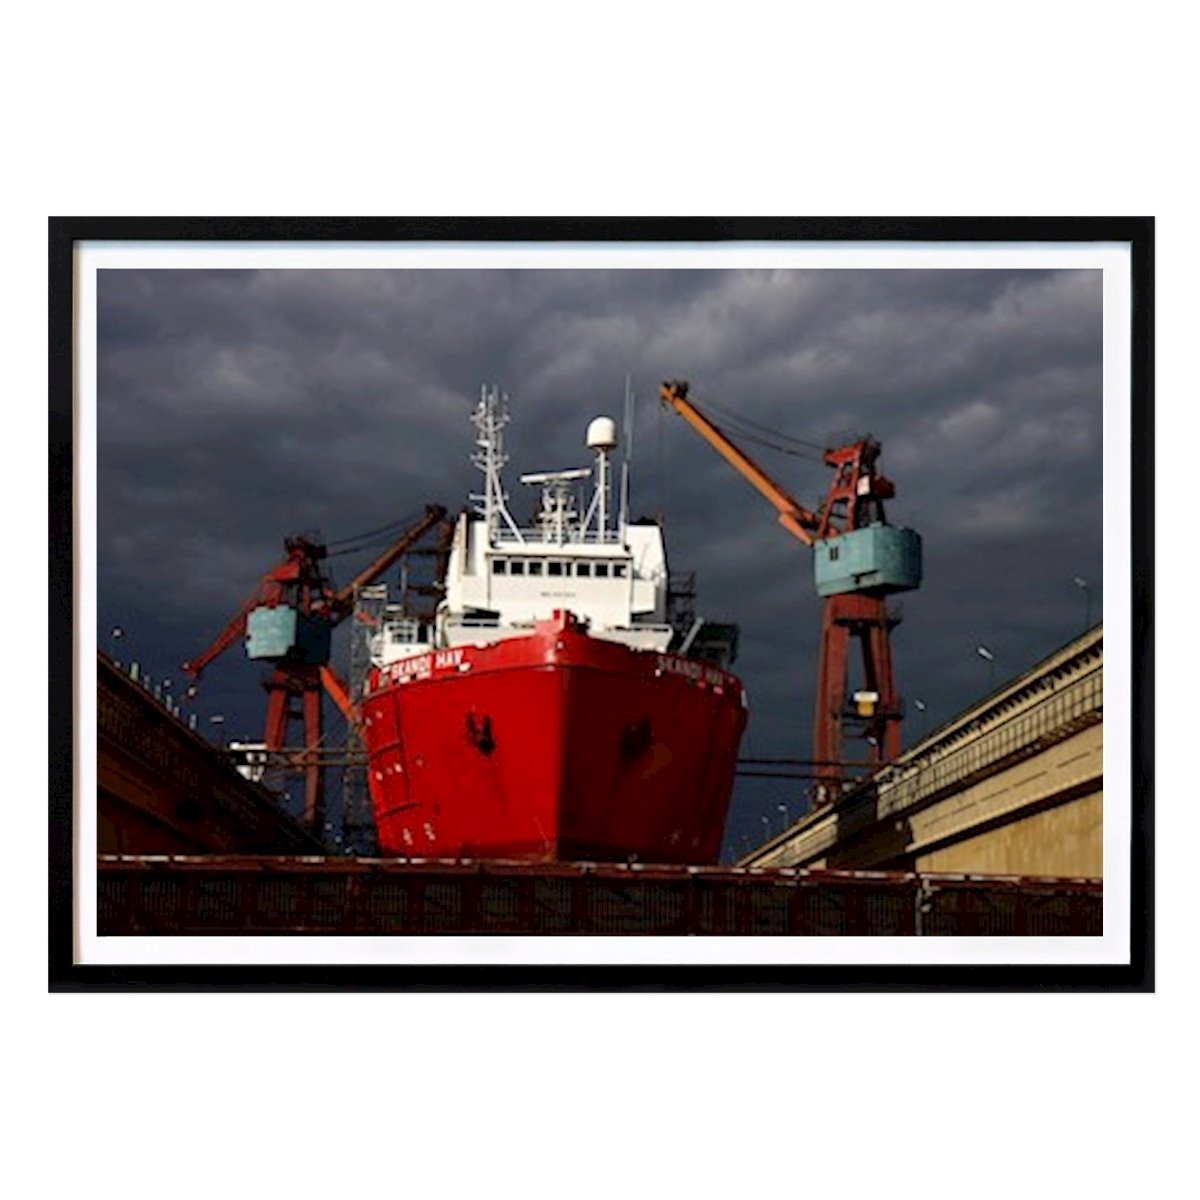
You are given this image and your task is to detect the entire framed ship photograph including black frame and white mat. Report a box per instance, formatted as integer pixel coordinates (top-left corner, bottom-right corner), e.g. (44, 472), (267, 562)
(49, 217), (1153, 990)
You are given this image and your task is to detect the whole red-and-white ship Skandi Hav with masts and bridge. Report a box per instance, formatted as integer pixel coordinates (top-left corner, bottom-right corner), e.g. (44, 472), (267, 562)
(361, 390), (746, 864)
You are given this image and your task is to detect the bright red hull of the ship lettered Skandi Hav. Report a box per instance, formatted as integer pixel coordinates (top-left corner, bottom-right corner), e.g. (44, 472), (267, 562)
(362, 613), (745, 864)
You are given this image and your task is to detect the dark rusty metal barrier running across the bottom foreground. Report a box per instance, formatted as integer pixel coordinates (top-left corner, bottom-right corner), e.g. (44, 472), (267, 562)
(97, 856), (1103, 936)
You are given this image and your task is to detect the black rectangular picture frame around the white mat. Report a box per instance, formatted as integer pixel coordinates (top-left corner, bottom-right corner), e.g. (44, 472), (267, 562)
(48, 217), (1154, 992)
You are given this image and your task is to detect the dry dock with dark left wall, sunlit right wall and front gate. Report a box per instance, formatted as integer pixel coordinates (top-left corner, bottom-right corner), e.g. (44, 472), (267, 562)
(97, 629), (1103, 936)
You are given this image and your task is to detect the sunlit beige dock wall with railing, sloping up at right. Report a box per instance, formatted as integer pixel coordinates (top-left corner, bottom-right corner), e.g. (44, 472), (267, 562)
(740, 625), (1104, 878)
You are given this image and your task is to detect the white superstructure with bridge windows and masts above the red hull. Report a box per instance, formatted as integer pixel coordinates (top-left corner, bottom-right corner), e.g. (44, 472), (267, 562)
(372, 388), (673, 666)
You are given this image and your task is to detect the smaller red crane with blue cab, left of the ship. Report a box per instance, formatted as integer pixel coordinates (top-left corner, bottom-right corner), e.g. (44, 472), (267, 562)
(184, 504), (446, 834)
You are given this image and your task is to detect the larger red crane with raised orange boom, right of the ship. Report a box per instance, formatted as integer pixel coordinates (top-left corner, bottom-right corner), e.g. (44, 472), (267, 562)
(660, 380), (920, 805)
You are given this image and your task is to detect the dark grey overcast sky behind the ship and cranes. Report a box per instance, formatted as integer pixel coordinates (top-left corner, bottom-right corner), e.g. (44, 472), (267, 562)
(97, 270), (1103, 851)
